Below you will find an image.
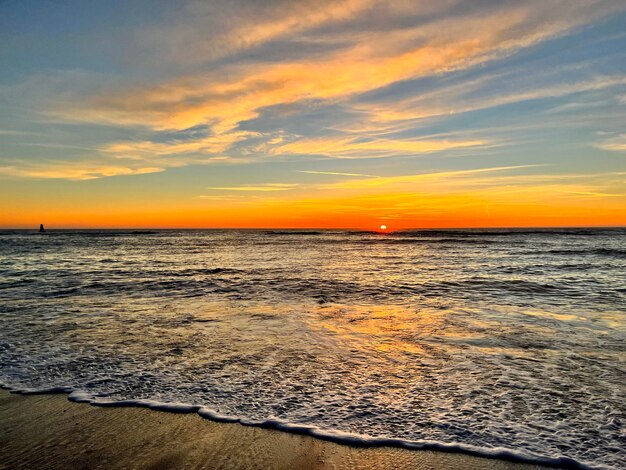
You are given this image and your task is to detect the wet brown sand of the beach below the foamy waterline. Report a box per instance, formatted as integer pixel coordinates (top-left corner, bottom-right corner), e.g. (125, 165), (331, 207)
(0, 390), (542, 470)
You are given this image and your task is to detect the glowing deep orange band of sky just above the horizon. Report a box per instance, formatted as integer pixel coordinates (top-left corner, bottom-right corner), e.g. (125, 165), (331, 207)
(3, 174), (626, 230)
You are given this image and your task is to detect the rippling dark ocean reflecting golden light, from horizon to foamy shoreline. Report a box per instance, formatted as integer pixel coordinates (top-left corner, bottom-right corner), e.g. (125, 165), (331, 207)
(0, 229), (626, 468)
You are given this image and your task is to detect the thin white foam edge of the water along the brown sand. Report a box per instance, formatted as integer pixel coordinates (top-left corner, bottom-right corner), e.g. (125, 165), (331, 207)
(0, 382), (613, 470)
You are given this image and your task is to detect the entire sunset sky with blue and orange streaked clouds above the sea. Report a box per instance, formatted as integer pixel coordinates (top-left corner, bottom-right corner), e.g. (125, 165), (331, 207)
(0, 0), (626, 229)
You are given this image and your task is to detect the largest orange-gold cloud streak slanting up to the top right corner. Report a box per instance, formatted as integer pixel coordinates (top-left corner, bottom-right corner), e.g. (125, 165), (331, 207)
(50, 1), (616, 134)
